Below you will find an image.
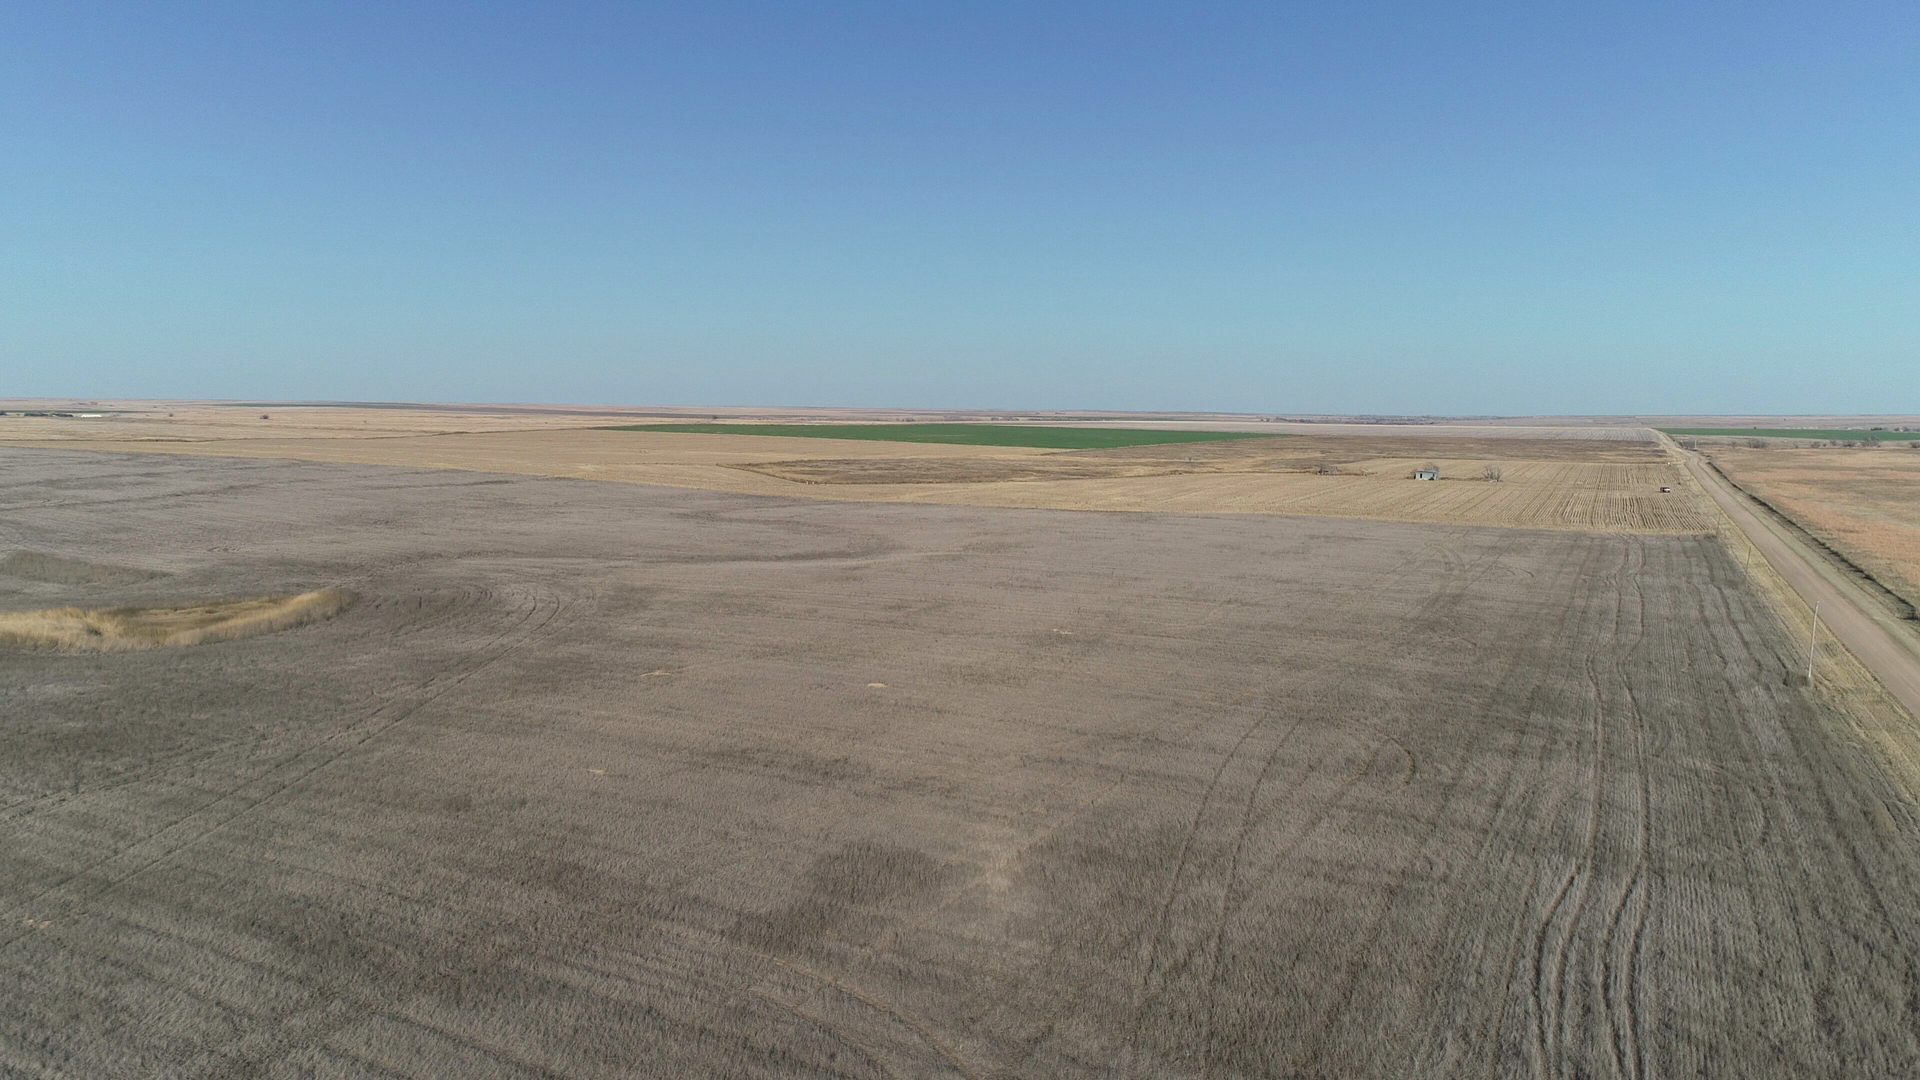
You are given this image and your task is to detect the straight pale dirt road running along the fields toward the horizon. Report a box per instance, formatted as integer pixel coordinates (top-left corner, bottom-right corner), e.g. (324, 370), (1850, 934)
(1682, 452), (1920, 715)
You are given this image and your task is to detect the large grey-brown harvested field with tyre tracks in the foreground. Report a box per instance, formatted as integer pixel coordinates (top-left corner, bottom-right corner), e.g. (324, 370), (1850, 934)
(0, 450), (1920, 1078)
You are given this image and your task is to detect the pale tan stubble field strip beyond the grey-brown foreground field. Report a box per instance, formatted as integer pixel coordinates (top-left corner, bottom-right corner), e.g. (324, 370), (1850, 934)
(0, 407), (1711, 532)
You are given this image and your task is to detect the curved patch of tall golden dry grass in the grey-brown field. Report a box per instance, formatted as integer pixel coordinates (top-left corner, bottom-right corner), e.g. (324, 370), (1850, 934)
(0, 588), (357, 651)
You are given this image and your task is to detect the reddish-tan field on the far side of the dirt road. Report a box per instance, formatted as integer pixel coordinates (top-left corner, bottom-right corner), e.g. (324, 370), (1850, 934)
(1713, 448), (1920, 607)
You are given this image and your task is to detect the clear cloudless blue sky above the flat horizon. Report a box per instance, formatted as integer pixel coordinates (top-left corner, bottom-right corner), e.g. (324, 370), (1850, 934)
(0, 0), (1920, 413)
